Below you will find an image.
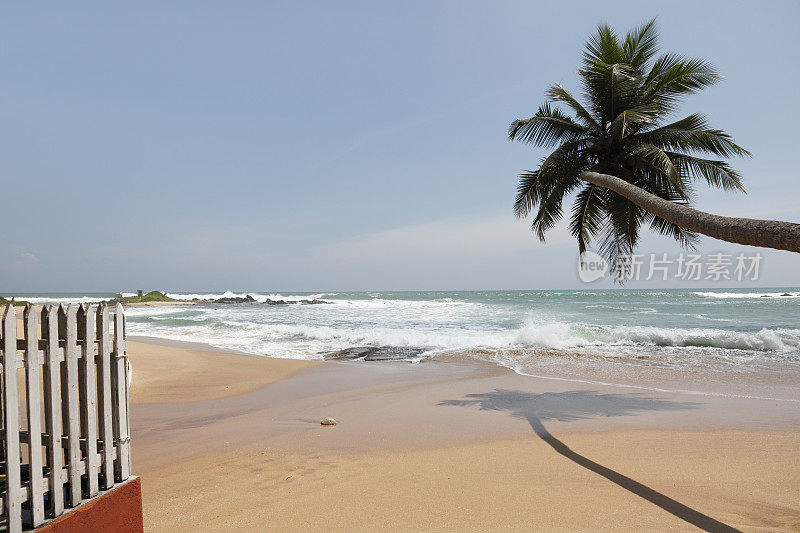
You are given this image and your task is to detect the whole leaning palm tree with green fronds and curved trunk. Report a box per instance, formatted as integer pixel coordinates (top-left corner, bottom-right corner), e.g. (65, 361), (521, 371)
(508, 20), (800, 264)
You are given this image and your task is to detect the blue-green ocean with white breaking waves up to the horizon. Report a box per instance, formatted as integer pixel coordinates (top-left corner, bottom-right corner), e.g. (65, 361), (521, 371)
(9, 287), (800, 382)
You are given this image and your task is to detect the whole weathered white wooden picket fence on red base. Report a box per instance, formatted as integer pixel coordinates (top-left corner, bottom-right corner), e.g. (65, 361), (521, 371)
(0, 303), (131, 533)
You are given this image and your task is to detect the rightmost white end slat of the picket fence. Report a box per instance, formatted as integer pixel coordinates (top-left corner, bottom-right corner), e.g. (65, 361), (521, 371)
(111, 303), (131, 481)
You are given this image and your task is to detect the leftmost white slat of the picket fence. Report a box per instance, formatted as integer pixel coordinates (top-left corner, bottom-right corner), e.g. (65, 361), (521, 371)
(3, 305), (23, 533)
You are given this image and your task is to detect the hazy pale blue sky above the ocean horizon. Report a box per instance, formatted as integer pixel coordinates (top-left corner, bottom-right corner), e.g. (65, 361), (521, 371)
(0, 0), (800, 292)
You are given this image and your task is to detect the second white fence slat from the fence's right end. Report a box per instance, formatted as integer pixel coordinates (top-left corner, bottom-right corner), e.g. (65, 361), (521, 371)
(96, 302), (115, 489)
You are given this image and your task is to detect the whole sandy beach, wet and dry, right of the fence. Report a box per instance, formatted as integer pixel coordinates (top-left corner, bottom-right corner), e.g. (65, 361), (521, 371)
(129, 341), (800, 531)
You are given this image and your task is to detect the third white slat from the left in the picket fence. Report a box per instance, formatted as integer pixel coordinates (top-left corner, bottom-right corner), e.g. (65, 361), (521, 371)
(42, 305), (64, 516)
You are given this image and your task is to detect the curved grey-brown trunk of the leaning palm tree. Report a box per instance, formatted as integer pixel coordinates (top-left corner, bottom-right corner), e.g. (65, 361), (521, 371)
(580, 172), (800, 252)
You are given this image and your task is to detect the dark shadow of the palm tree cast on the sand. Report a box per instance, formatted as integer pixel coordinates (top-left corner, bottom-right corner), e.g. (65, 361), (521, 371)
(439, 389), (738, 531)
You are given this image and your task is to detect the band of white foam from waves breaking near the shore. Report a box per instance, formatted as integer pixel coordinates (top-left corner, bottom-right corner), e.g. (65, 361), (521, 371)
(129, 308), (800, 358)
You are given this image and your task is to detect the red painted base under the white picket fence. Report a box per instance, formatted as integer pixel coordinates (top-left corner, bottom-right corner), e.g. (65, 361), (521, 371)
(36, 477), (144, 533)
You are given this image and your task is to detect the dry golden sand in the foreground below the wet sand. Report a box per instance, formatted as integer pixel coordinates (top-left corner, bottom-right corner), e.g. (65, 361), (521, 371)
(139, 431), (800, 531)
